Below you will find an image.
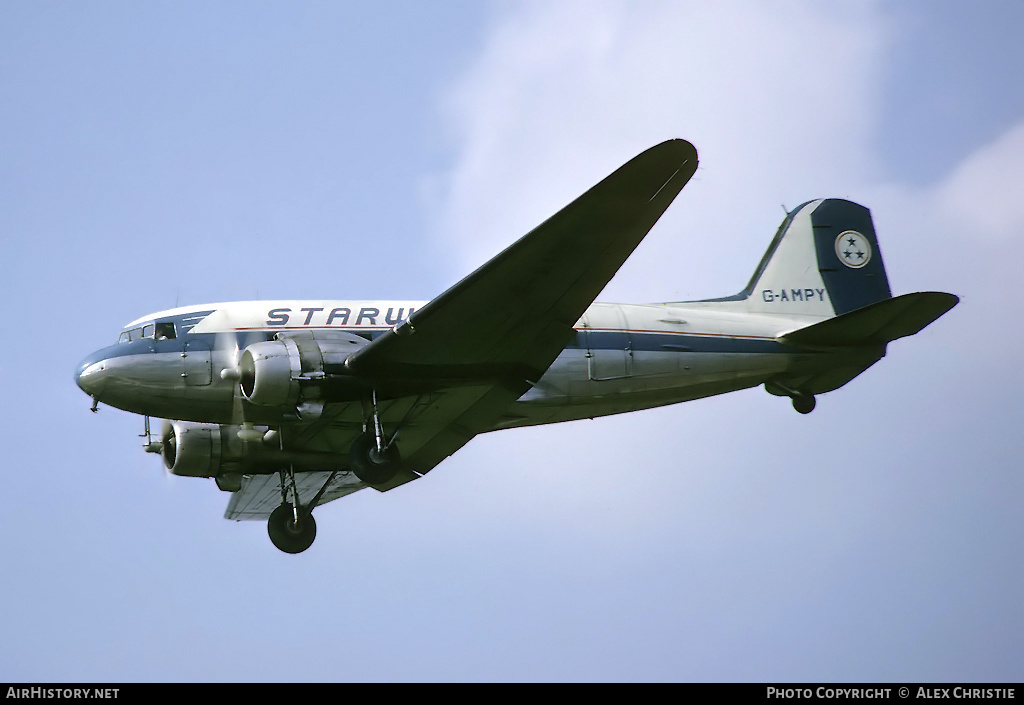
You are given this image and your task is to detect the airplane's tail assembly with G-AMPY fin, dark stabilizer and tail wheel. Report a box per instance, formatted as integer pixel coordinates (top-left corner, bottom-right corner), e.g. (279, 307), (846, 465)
(749, 199), (959, 407)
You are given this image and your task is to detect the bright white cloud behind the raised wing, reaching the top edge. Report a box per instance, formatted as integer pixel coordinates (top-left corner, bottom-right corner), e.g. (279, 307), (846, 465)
(435, 0), (886, 300)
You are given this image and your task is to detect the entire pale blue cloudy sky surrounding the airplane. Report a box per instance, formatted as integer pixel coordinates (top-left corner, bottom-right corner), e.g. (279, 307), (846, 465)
(0, 0), (1024, 681)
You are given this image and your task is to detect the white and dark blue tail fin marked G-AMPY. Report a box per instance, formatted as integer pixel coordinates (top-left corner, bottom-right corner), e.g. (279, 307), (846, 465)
(741, 199), (892, 318)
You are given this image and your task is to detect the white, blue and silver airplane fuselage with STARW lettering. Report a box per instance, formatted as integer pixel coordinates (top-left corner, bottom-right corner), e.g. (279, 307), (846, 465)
(77, 300), (851, 428)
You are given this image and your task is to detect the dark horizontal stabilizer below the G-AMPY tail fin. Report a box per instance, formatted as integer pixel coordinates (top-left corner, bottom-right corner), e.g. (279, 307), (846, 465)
(778, 291), (959, 350)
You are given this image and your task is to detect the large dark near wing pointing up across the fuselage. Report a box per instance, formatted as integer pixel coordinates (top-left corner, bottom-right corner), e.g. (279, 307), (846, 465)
(345, 139), (697, 490)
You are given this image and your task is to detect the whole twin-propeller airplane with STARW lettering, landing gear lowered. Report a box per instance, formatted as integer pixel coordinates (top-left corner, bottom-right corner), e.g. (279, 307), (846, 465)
(75, 139), (958, 553)
